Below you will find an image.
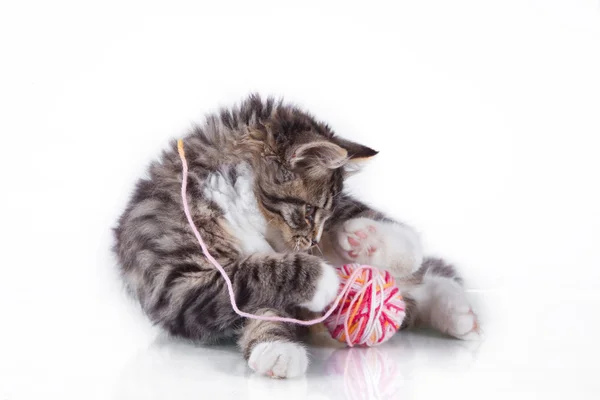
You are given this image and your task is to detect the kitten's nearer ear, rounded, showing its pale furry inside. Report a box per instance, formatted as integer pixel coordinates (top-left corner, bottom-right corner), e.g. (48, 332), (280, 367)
(288, 141), (348, 174)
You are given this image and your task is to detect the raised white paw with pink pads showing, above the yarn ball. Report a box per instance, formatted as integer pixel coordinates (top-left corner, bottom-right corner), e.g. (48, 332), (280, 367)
(336, 218), (423, 276)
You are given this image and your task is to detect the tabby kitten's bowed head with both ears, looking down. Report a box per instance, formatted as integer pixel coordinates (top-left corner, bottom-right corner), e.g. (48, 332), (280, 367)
(251, 103), (377, 251)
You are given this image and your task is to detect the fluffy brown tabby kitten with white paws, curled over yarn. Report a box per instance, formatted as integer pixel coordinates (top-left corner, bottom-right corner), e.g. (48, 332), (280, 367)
(115, 95), (479, 377)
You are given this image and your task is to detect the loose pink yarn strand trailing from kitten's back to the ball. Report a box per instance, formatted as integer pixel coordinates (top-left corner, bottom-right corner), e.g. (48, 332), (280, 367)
(177, 139), (376, 330)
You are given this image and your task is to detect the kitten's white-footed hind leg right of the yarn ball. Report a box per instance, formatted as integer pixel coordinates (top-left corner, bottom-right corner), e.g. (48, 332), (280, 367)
(398, 258), (482, 340)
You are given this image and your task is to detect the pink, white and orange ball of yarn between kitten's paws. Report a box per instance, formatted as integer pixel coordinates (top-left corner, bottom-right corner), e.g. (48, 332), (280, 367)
(324, 264), (406, 347)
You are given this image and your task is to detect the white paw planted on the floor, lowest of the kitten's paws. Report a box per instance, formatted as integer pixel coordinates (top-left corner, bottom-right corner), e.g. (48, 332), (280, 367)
(248, 341), (308, 378)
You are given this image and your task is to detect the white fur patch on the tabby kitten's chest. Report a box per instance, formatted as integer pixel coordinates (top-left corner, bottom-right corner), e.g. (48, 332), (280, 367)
(204, 164), (273, 254)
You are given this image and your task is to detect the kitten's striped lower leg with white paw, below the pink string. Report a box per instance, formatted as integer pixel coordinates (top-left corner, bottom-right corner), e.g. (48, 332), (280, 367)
(238, 309), (308, 378)
